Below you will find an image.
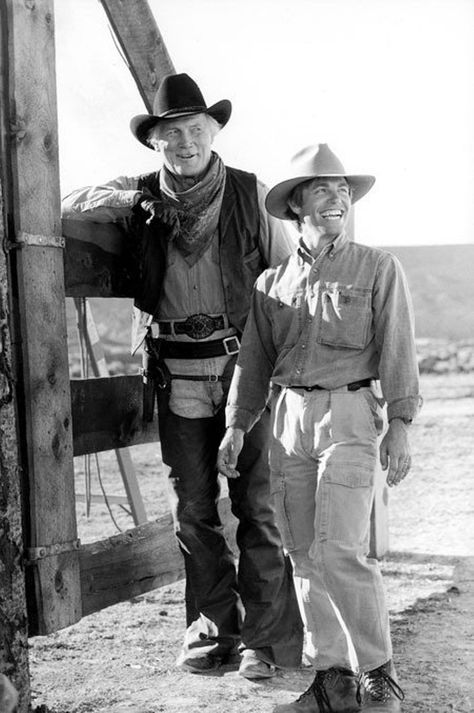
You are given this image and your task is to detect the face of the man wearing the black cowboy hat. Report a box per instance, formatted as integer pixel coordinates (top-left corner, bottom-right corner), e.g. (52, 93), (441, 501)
(150, 114), (213, 177)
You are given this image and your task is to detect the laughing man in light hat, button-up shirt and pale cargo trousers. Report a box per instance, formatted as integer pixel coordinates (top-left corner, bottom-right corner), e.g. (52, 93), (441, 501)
(218, 144), (420, 713)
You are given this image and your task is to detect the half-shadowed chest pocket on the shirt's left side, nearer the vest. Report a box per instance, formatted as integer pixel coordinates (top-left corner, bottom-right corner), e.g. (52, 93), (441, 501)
(266, 291), (304, 351)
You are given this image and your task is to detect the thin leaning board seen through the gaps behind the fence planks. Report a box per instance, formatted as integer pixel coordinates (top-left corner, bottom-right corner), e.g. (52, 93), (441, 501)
(75, 299), (147, 525)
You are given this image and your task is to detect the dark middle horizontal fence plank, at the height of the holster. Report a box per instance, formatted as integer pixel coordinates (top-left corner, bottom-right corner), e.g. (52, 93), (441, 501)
(71, 375), (158, 456)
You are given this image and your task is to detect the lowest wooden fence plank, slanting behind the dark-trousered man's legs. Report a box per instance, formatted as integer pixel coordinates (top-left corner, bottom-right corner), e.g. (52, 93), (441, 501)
(79, 498), (237, 616)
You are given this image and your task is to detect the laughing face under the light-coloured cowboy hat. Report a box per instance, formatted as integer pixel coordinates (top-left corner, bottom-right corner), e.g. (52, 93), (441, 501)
(293, 178), (351, 236)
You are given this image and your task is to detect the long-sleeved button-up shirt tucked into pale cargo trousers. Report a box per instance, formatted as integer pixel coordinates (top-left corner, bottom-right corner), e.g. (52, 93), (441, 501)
(226, 234), (421, 431)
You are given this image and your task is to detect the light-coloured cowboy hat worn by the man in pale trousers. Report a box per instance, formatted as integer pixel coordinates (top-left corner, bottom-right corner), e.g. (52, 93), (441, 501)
(265, 144), (375, 220)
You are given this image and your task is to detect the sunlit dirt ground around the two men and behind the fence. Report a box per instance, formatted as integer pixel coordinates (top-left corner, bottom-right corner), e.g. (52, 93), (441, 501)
(30, 374), (474, 713)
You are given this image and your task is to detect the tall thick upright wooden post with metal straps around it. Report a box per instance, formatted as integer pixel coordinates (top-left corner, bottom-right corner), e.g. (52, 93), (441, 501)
(7, 0), (82, 634)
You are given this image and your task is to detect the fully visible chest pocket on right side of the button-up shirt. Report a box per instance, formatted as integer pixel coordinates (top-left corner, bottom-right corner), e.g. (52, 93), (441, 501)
(316, 282), (372, 349)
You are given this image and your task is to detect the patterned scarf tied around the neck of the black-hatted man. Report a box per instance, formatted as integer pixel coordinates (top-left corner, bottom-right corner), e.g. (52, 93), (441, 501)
(160, 152), (225, 265)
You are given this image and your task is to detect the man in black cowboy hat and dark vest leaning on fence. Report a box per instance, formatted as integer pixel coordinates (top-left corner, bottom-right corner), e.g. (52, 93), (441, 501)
(63, 74), (303, 678)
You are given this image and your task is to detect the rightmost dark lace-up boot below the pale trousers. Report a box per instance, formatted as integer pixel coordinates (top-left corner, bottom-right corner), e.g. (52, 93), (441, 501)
(361, 661), (405, 713)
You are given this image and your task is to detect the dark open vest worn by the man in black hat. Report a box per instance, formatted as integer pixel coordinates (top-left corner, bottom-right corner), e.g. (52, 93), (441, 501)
(132, 166), (262, 354)
